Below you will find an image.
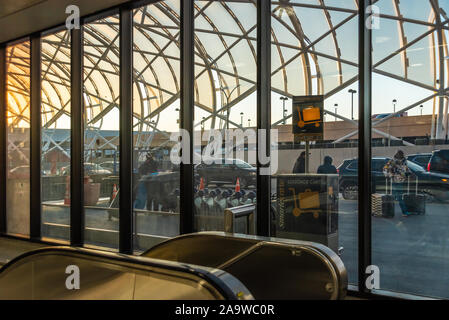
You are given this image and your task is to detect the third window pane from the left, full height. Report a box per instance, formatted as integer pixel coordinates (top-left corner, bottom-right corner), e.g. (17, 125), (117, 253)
(82, 16), (120, 248)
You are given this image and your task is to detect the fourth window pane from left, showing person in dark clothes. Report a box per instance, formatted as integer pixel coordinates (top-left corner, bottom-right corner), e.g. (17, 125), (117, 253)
(133, 0), (180, 251)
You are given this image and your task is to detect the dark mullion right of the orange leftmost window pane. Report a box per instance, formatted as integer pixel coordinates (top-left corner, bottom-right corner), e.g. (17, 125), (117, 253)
(30, 34), (42, 240)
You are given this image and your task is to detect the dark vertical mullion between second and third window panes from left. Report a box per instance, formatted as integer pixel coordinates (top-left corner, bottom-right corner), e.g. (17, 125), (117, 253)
(70, 26), (84, 246)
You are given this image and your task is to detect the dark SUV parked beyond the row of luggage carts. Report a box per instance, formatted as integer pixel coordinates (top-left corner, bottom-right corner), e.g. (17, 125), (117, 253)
(195, 159), (257, 188)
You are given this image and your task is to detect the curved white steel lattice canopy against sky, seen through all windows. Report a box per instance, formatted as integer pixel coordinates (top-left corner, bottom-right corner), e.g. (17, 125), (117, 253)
(7, 0), (449, 162)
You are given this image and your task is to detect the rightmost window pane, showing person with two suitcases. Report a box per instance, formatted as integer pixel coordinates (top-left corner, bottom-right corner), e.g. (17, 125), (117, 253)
(371, 1), (449, 298)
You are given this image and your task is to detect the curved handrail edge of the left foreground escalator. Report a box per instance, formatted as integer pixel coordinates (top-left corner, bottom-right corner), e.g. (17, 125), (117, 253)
(0, 246), (253, 300)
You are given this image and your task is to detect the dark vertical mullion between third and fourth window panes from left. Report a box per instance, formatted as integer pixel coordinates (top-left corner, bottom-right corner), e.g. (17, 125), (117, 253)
(119, 7), (134, 254)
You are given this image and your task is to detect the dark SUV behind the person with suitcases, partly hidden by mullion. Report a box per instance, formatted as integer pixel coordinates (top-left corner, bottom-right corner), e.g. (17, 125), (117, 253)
(338, 157), (449, 201)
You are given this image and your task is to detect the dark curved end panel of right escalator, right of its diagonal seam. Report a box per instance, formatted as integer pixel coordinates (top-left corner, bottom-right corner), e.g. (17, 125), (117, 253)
(223, 244), (345, 300)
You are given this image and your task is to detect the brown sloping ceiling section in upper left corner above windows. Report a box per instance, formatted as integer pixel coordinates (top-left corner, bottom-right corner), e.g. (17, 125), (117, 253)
(0, 0), (132, 43)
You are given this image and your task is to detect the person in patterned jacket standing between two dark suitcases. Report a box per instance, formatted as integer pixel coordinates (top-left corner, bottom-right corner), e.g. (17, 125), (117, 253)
(383, 150), (411, 217)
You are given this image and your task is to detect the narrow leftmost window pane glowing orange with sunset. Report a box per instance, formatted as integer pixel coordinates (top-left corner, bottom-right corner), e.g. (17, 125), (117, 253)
(6, 41), (30, 235)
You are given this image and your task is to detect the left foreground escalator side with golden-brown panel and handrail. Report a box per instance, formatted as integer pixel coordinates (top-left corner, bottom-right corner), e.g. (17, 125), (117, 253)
(0, 248), (252, 300)
